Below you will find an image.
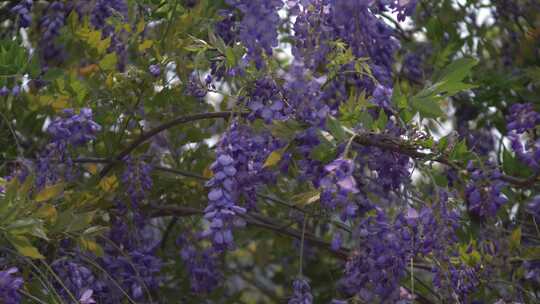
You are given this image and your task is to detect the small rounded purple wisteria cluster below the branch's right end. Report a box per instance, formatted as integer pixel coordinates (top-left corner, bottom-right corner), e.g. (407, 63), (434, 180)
(465, 162), (508, 218)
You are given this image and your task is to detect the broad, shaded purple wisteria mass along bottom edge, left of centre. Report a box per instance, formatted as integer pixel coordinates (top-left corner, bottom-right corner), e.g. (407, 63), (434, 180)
(47, 216), (163, 304)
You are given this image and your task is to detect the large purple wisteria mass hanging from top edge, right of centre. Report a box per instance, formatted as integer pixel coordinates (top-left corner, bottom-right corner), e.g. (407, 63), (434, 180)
(293, 0), (399, 88)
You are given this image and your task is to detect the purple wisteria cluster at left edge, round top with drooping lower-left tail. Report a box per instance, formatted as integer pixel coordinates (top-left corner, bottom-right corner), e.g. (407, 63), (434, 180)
(36, 108), (101, 188)
